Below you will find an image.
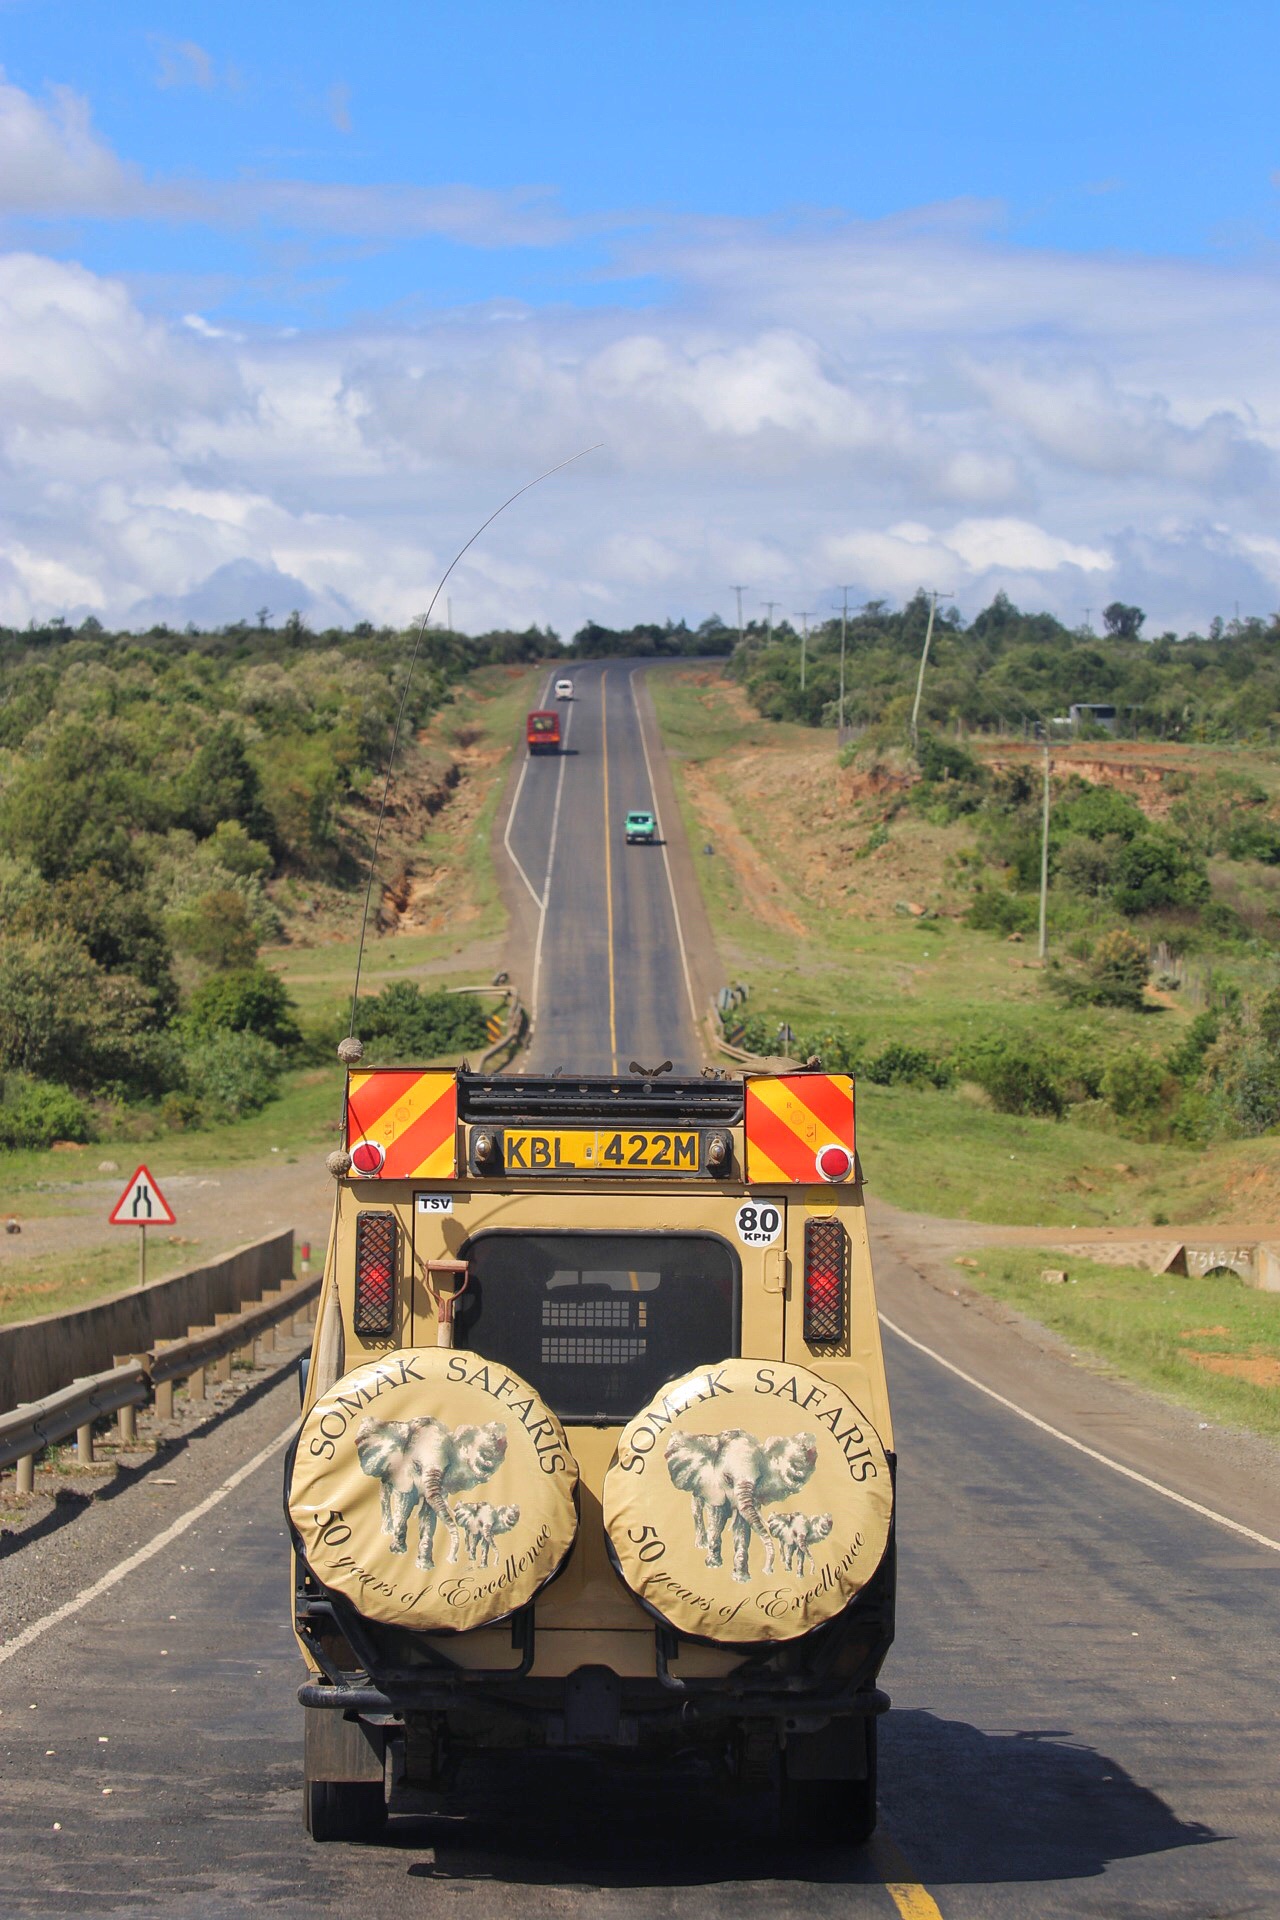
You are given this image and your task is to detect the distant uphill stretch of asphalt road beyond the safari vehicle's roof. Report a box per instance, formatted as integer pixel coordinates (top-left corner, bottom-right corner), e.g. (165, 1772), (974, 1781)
(507, 660), (702, 1073)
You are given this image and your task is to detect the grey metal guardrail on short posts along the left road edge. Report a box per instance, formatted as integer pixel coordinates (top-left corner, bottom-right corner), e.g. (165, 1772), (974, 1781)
(0, 1275), (320, 1494)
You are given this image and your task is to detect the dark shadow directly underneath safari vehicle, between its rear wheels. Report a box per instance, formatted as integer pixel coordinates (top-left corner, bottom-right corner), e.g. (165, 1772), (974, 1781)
(386, 1753), (881, 1889)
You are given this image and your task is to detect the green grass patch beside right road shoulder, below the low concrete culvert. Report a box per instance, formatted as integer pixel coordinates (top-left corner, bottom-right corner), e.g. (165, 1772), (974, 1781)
(965, 1246), (1280, 1434)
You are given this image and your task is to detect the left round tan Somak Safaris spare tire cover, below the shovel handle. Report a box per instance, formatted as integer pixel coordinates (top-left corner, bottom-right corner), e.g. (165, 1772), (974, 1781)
(288, 1348), (578, 1632)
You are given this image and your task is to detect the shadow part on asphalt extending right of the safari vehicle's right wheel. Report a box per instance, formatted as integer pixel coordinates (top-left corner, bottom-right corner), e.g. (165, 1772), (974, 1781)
(881, 1709), (1226, 1887)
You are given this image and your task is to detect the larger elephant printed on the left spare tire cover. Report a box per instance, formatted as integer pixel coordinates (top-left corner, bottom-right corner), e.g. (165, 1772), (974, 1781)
(355, 1413), (507, 1567)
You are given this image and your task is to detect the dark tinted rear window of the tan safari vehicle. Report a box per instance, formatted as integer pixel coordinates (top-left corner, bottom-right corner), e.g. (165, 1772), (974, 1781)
(455, 1233), (741, 1425)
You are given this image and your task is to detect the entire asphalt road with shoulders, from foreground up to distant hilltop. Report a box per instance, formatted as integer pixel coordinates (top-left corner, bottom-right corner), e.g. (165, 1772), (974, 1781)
(0, 666), (1280, 1920)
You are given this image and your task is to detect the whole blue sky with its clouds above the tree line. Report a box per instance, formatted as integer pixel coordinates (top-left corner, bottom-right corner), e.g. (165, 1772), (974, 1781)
(0, 0), (1280, 628)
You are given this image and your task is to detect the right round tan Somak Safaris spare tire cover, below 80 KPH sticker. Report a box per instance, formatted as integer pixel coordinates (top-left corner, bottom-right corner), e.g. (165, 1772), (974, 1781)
(604, 1359), (892, 1644)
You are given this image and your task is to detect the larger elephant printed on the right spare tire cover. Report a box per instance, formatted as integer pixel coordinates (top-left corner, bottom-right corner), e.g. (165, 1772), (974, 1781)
(666, 1427), (818, 1580)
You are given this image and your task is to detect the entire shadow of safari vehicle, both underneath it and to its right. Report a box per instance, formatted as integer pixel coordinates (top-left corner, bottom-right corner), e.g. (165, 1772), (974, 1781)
(386, 1711), (1224, 1887)
